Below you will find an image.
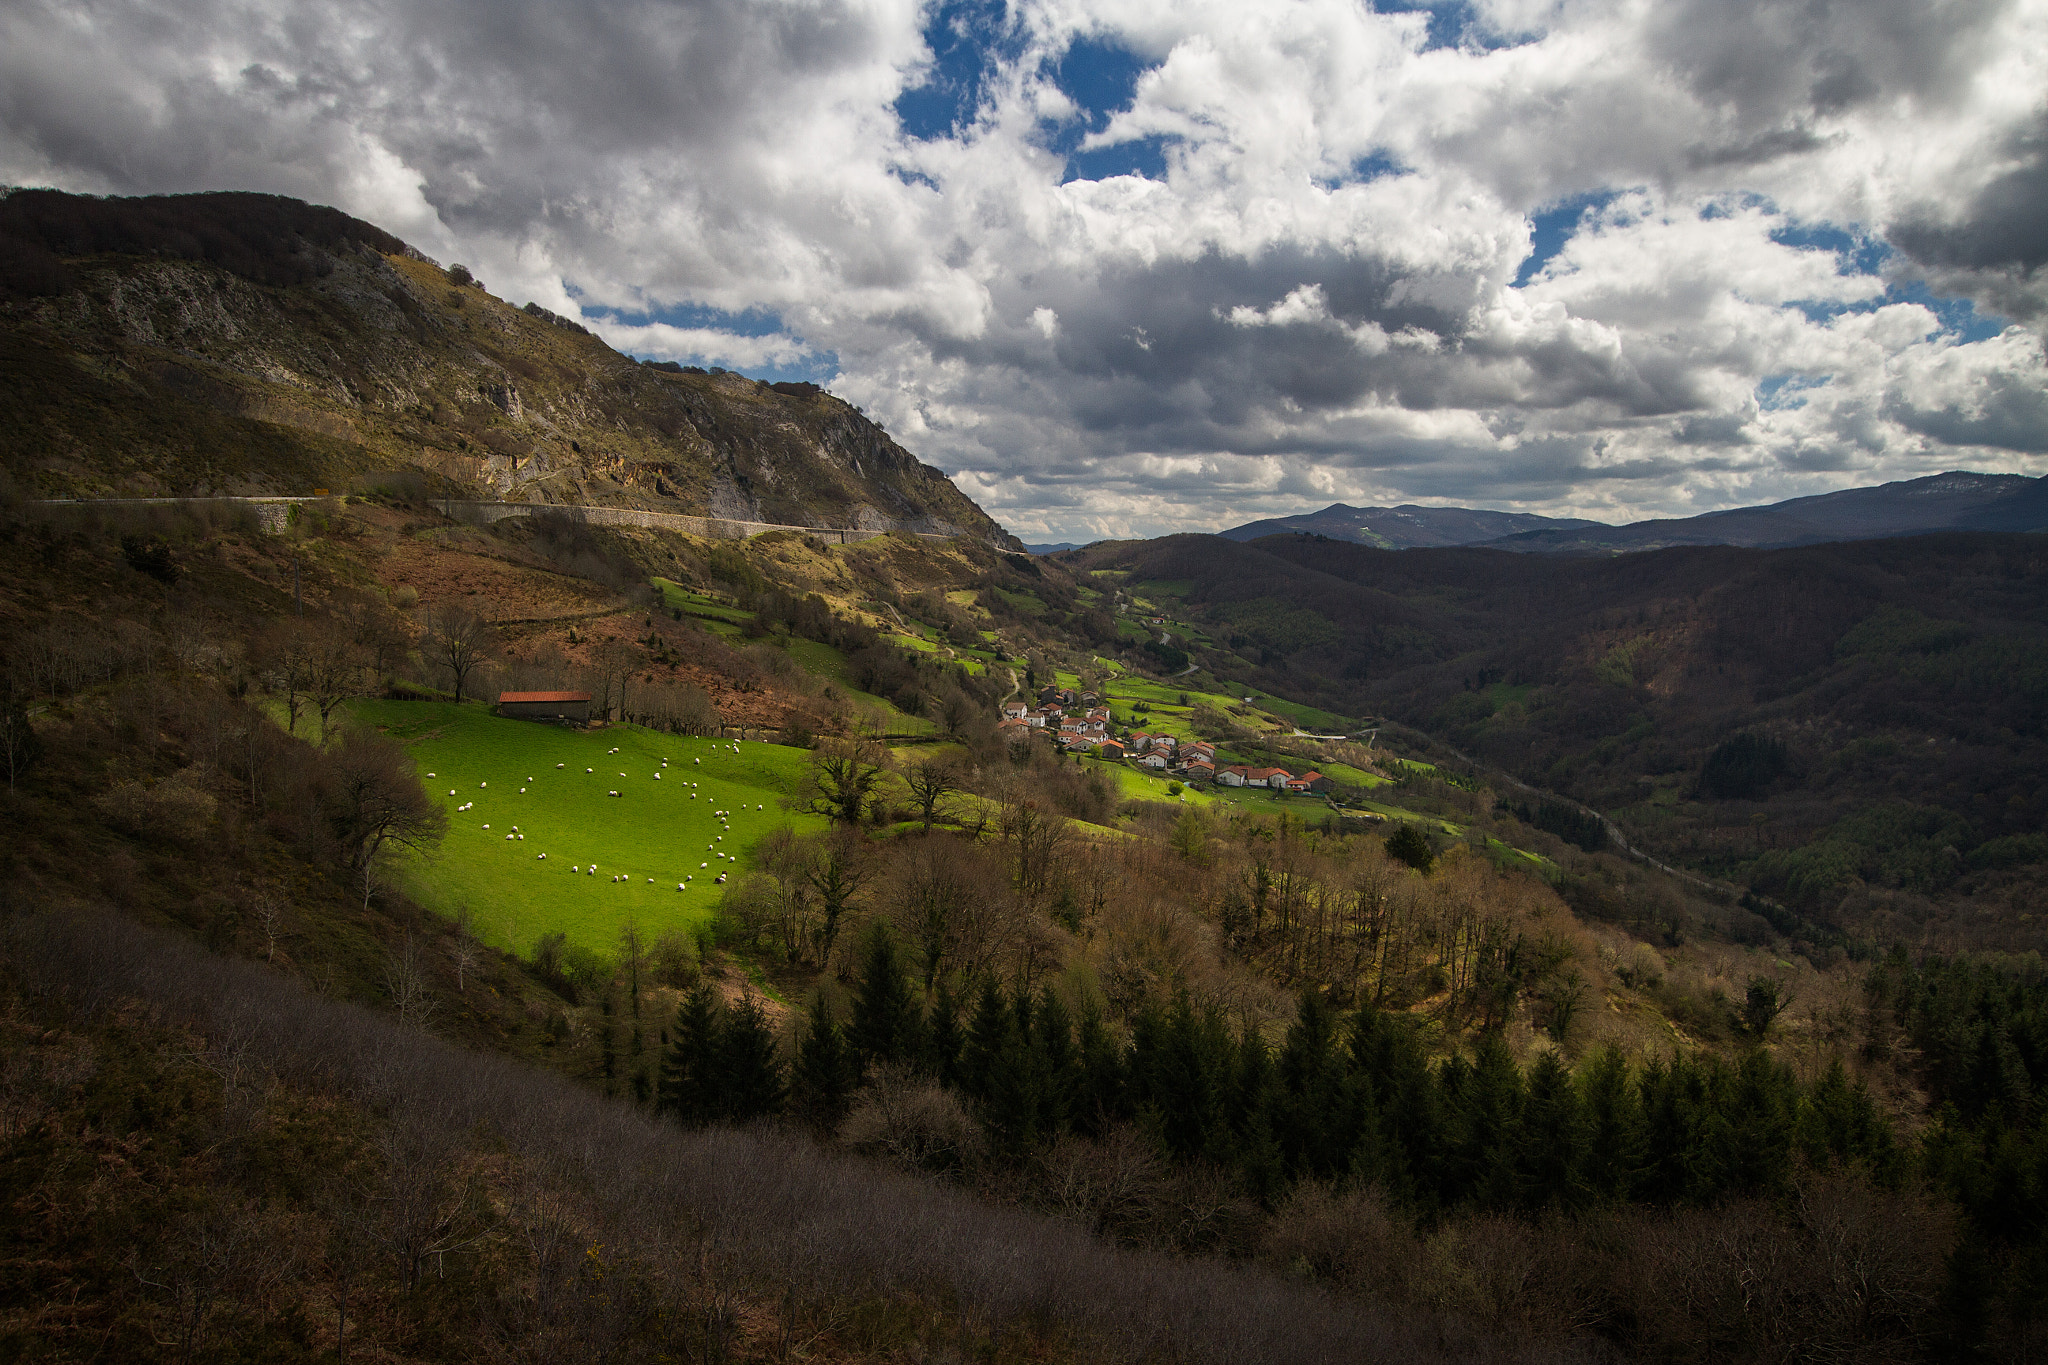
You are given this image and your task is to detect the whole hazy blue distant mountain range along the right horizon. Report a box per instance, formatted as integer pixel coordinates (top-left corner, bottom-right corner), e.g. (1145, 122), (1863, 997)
(1219, 471), (2048, 555)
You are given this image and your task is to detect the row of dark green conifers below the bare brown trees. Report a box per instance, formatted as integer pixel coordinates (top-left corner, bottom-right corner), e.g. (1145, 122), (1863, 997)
(662, 931), (1905, 1214)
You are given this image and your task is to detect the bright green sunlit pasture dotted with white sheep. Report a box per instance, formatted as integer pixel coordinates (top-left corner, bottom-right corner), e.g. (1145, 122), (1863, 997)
(354, 702), (825, 954)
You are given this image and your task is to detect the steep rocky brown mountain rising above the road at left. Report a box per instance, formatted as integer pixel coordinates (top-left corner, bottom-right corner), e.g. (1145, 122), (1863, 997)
(0, 190), (1016, 548)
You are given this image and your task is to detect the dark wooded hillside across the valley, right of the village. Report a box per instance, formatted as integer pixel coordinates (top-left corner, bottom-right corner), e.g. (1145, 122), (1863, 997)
(1063, 534), (2048, 948)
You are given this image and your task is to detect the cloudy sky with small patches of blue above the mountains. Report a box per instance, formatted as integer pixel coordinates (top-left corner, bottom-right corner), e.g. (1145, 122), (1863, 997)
(0, 0), (2048, 542)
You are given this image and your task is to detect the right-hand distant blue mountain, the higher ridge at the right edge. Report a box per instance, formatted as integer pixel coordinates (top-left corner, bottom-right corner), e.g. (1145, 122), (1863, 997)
(1474, 471), (2048, 555)
